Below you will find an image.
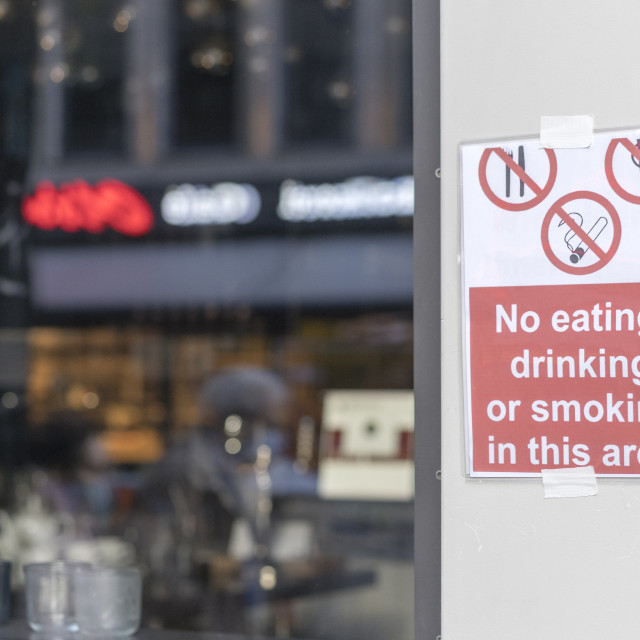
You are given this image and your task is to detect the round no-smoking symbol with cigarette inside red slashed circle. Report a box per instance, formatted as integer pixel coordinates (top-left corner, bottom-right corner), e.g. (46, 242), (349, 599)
(541, 191), (621, 275)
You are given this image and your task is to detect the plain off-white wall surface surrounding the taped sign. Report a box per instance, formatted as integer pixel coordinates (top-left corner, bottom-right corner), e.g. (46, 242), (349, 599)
(436, 0), (640, 640)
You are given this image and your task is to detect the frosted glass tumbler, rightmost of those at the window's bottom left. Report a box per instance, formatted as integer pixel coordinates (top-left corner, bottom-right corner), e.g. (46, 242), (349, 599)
(75, 567), (142, 637)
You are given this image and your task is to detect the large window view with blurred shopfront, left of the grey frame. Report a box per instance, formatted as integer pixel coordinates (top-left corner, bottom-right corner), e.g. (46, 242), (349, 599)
(0, 0), (420, 640)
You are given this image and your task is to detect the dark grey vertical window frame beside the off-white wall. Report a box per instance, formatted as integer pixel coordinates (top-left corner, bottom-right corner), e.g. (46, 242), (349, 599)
(413, 0), (440, 640)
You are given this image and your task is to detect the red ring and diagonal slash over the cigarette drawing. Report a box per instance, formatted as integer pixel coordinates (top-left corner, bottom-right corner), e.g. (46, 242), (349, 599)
(541, 191), (622, 275)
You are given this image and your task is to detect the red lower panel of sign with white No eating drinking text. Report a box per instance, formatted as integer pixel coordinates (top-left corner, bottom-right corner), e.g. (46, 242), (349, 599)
(468, 282), (640, 476)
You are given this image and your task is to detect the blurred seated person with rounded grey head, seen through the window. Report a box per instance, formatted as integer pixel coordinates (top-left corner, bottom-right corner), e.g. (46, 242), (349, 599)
(131, 367), (312, 631)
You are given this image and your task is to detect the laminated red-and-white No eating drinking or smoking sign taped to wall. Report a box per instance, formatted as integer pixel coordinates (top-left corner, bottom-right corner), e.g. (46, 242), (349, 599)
(460, 129), (640, 476)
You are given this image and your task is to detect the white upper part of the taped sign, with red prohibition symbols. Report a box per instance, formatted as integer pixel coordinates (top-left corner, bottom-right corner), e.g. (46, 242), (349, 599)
(461, 129), (640, 286)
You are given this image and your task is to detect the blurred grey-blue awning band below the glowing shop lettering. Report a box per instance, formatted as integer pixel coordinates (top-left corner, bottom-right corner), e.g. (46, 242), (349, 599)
(30, 234), (413, 311)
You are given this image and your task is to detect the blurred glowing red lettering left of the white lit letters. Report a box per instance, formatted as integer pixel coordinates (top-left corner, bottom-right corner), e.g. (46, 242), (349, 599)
(22, 179), (153, 236)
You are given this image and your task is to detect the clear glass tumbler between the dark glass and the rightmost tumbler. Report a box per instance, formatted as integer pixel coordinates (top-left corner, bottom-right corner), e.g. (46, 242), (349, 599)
(24, 562), (87, 633)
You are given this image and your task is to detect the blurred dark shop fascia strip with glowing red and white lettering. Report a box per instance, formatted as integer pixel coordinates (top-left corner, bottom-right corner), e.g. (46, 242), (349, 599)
(22, 175), (414, 245)
